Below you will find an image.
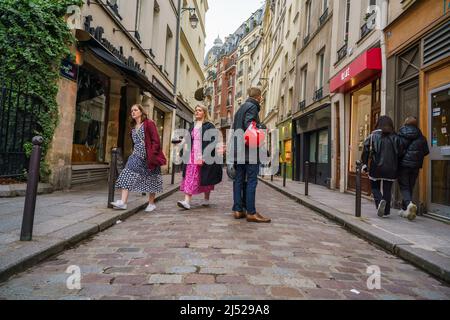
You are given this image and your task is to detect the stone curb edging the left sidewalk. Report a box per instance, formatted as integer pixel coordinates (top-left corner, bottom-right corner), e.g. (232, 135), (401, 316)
(0, 186), (179, 283)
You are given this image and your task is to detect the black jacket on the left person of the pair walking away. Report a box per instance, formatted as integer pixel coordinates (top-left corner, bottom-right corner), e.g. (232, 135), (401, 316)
(361, 130), (403, 180)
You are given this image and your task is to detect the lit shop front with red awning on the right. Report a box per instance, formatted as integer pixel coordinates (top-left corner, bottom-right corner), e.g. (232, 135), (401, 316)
(330, 48), (382, 195)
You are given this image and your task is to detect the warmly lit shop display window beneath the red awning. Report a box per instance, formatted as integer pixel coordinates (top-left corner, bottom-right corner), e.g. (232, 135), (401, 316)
(349, 84), (372, 172)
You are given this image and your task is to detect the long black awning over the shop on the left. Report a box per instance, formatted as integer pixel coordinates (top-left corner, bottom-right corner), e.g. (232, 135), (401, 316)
(80, 37), (177, 109)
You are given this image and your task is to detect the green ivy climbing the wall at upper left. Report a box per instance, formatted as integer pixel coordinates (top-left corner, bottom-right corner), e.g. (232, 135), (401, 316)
(0, 0), (83, 179)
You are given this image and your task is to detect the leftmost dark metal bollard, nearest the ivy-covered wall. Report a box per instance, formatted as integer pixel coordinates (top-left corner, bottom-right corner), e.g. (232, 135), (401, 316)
(20, 136), (44, 241)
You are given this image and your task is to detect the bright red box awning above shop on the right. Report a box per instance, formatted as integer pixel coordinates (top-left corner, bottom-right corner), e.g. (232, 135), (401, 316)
(330, 48), (382, 93)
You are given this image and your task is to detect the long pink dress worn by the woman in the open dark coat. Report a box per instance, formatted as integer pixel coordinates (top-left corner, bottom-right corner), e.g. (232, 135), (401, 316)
(180, 128), (214, 195)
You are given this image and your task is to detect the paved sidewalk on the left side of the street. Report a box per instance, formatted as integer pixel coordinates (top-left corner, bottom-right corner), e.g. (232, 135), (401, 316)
(0, 174), (181, 281)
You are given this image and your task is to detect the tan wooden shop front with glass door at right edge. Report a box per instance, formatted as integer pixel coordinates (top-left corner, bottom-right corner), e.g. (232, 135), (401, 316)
(385, 0), (450, 221)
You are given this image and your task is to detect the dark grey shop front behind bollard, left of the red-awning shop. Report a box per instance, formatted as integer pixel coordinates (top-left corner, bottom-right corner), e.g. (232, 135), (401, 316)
(294, 104), (331, 187)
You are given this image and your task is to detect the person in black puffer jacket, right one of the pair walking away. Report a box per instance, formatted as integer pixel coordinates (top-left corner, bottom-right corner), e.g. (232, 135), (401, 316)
(398, 117), (430, 220)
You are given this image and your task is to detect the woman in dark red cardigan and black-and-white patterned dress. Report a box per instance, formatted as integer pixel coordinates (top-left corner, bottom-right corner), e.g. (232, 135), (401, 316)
(111, 104), (167, 212)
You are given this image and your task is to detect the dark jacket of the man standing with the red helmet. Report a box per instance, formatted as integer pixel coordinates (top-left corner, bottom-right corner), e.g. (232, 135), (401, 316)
(232, 98), (263, 163)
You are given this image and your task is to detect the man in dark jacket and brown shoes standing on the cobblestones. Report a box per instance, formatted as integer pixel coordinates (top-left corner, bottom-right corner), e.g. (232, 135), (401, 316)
(231, 88), (271, 223)
